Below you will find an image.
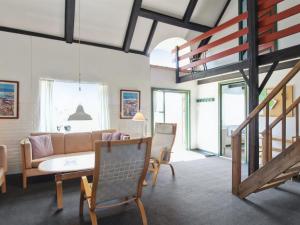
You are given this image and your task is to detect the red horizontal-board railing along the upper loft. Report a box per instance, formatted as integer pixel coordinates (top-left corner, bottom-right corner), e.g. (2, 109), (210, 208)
(172, 0), (300, 81)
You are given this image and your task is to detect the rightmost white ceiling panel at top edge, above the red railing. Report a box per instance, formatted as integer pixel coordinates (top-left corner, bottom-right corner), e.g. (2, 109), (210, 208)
(191, 0), (227, 27)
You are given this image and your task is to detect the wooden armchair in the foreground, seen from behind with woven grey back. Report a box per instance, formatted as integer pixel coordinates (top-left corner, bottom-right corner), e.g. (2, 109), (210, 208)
(80, 138), (151, 225)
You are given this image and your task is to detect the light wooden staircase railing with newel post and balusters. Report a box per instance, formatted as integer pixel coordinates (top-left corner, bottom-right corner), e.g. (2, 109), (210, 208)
(232, 61), (300, 195)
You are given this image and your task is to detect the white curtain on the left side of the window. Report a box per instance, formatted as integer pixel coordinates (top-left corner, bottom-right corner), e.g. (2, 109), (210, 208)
(39, 80), (55, 132)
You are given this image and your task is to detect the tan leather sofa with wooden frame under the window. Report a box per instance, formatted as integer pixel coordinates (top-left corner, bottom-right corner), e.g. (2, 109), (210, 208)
(21, 129), (116, 189)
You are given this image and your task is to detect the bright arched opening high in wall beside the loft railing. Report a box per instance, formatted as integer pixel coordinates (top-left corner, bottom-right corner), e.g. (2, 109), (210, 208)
(150, 37), (191, 68)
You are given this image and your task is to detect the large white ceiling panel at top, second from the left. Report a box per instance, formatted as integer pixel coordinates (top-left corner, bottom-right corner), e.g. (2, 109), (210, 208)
(74, 0), (133, 47)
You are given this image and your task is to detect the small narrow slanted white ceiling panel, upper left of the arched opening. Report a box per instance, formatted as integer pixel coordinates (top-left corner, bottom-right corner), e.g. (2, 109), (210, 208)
(130, 17), (153, 51)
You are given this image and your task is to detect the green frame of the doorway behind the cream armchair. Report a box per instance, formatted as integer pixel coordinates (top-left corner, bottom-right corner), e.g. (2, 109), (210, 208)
(151, 87), (191, 150)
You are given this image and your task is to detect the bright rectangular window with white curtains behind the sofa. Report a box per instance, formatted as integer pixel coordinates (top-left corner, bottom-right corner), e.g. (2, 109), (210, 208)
(40, 80), (109, 132)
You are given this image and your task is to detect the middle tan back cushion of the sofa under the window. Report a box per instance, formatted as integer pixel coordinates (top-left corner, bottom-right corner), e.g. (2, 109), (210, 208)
(65, 132), (93, 154)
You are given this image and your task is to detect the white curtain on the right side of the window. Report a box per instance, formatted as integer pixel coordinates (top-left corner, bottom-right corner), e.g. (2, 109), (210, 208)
(98, 84), (110, 130)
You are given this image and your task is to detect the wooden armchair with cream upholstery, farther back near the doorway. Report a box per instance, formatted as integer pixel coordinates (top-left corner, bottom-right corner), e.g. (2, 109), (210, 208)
(150, 123), (177, 185)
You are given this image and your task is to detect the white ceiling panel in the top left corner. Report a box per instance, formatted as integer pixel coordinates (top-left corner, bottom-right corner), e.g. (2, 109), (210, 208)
(0, 0), (65, 37)
